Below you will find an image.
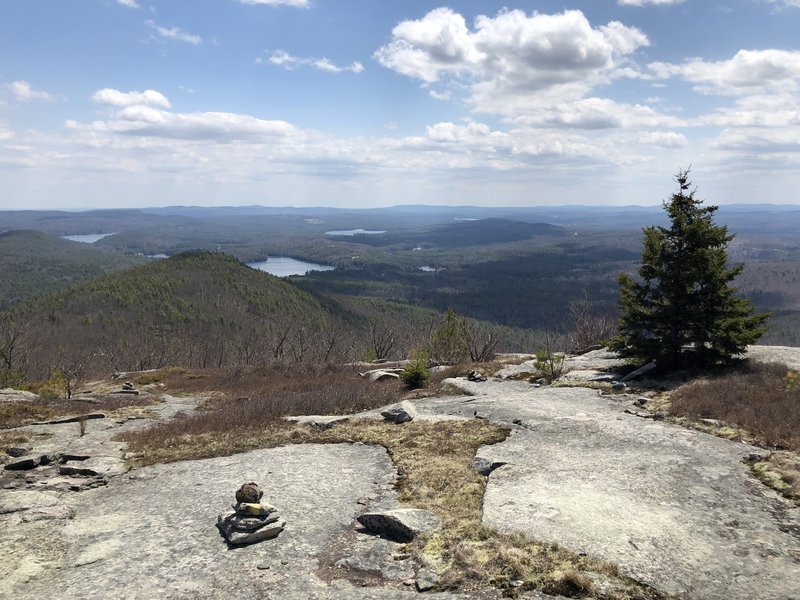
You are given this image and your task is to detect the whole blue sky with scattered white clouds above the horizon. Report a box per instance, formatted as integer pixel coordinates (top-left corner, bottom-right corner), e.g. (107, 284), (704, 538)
(0, 0), (800, 210)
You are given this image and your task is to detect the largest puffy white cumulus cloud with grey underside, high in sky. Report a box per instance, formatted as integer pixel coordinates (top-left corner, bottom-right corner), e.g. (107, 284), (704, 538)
(375, 8), (649, 114)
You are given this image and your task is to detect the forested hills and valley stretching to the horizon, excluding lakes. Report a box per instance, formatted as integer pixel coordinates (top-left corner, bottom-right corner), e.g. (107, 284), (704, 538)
(0, 207), (800, 384)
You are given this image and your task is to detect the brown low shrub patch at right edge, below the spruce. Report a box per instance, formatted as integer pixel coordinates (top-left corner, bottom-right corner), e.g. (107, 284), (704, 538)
(670, 363), (800, 450)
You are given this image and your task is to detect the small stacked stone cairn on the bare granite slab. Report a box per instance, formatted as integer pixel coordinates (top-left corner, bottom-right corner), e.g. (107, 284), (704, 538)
(217, 483), (286, 546)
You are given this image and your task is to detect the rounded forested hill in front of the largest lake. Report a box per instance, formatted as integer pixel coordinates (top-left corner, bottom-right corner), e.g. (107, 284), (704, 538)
(14, 252), (346, 377)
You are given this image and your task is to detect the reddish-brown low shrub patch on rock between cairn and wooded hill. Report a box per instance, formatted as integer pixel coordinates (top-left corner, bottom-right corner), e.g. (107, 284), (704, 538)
(117, 366), (403, 465)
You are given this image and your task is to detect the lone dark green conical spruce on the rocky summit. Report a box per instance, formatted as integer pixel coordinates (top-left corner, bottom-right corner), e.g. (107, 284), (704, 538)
(611, 169), (769, 368)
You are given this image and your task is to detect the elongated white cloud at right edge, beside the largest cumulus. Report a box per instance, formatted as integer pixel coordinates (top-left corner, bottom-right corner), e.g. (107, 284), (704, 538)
(648, 49), (800, 95)
